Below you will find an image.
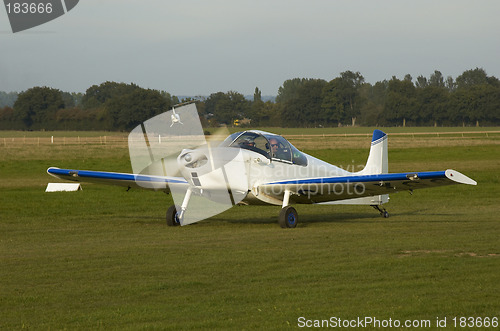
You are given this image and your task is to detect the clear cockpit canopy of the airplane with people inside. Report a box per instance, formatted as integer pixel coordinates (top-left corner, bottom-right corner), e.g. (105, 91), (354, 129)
(220, 131), (307, 166)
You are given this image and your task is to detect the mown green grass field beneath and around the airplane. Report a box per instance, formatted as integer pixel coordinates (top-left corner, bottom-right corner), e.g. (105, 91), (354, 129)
(0, 132), (500, 330)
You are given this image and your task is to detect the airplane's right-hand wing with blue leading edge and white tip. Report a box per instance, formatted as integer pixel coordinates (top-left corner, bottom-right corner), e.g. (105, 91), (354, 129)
(258, 169), (477, 203)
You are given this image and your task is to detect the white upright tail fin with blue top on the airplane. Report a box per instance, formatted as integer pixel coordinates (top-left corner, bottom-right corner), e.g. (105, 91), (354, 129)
(359, 130), (389, 175)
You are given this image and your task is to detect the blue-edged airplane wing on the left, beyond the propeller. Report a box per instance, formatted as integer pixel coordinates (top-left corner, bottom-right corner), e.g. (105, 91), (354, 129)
(47, 167), (188, 191)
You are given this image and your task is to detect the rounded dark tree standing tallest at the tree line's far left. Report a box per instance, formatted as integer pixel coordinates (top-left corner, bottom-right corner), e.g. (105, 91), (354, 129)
(14, 87), (64, 129)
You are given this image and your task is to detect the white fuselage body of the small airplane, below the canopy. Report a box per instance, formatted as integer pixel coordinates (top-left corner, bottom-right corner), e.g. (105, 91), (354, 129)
(179, 147), (352, 205)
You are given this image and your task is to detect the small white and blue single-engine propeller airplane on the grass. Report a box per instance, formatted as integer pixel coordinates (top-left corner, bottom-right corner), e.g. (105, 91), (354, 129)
(47, 104), (477, 228)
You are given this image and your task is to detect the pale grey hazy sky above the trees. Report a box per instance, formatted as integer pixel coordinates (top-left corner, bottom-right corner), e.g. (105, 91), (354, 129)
(0, 0), (500, 96)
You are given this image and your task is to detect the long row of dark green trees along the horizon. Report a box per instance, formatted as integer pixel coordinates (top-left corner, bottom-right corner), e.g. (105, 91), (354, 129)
(0, 68), (500, 131)
